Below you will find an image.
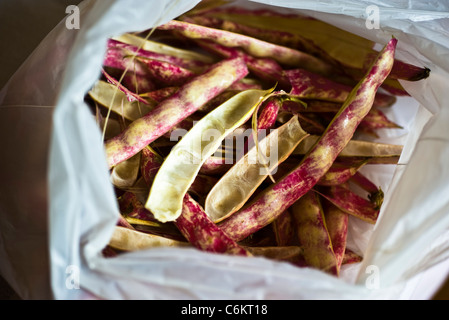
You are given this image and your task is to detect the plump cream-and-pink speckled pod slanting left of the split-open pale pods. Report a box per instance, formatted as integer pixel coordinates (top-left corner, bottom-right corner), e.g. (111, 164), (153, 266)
(105, 58), (248, 167)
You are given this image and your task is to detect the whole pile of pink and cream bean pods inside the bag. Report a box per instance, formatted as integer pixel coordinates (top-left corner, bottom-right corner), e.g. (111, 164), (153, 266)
(85, 2), (430, 276)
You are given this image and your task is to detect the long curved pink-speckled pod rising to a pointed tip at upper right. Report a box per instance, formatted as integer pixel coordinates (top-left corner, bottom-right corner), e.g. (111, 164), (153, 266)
(219, 38), (397, 241)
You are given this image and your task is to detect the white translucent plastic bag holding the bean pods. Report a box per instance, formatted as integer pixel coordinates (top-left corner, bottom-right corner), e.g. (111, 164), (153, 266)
(0, 0), (449, 299)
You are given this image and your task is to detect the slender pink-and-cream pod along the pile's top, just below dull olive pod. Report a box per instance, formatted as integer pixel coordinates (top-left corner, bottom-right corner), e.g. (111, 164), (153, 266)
(158, 20), (335, 75)
